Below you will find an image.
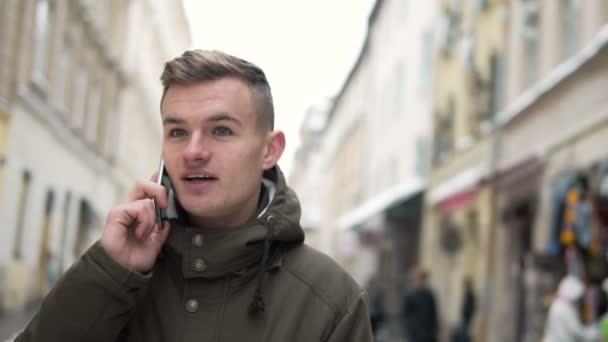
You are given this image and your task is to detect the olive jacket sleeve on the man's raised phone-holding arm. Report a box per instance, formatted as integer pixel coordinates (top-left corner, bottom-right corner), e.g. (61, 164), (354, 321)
(15, 242), (150, 342)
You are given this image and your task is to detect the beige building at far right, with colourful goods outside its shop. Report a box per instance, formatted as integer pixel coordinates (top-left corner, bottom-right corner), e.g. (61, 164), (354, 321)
(487, 0), (608, 341)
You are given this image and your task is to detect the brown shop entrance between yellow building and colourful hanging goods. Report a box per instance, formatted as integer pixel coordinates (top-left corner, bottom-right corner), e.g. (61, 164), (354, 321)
(489, 156), (553, 341)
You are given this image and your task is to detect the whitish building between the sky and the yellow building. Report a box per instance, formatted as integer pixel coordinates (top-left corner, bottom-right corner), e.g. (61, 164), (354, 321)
(290, 0), (436, 336)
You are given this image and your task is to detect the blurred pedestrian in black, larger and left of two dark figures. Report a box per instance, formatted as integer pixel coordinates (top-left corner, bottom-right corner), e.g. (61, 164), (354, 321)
(401, 269), (439, 342)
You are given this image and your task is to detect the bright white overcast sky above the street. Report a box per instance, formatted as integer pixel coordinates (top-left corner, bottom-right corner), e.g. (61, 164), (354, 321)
(184, 0), (373, 172)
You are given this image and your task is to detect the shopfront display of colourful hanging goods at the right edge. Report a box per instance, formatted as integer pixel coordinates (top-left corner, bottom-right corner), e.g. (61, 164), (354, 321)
(547, 159), (608, 322)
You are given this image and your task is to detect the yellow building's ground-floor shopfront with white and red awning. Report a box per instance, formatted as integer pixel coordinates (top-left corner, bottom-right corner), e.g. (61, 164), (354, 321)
(423, 166), (492, 336)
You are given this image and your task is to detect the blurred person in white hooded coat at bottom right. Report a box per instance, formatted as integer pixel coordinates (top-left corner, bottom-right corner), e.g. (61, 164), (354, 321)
(543, 275), (600, 342)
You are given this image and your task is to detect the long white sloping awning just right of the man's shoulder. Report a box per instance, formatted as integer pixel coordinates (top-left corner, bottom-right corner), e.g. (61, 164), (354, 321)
(338, 178), (426, 230)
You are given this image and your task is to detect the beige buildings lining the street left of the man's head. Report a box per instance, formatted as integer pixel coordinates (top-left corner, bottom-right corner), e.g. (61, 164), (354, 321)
(0, 0), (190, 310)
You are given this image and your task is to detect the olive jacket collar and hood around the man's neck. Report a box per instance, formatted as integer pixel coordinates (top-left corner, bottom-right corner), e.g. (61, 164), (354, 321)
(165, 166), (304, 278)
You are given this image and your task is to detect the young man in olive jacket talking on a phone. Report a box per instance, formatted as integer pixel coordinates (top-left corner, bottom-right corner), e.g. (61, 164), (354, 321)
(16, 50), (372, 342)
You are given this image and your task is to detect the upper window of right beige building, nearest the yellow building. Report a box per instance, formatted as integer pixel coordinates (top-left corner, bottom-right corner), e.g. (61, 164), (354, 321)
(522, 2), (540, 86)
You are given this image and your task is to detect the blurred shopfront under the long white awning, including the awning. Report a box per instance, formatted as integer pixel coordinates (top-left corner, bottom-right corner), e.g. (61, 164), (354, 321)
(338, 179), (425, 329)
